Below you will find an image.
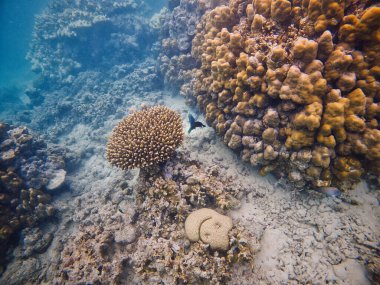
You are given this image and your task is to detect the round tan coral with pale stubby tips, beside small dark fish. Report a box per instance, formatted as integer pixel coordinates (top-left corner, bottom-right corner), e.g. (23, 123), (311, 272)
(107, 106), (184, 170)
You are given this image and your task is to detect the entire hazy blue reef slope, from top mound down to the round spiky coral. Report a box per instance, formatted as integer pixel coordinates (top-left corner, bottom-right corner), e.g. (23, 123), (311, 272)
(7, 0), (166, 138)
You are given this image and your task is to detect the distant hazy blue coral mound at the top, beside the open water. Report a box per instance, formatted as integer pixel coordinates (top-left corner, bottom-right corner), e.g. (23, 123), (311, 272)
(28, 0), (158, 85)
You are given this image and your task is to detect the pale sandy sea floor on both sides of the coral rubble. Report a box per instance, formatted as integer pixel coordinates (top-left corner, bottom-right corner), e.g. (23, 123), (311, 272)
(0, 91), (380, 285)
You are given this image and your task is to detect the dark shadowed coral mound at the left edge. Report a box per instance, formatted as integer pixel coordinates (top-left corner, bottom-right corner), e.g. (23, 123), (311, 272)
(0, 122), (66, 273)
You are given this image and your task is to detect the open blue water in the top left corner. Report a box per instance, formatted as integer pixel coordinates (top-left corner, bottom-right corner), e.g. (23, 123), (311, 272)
(0, 0), (49, 112)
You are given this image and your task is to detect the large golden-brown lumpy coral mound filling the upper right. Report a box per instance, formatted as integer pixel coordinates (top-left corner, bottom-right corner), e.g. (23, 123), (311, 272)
(188, 0), (380, 189)
